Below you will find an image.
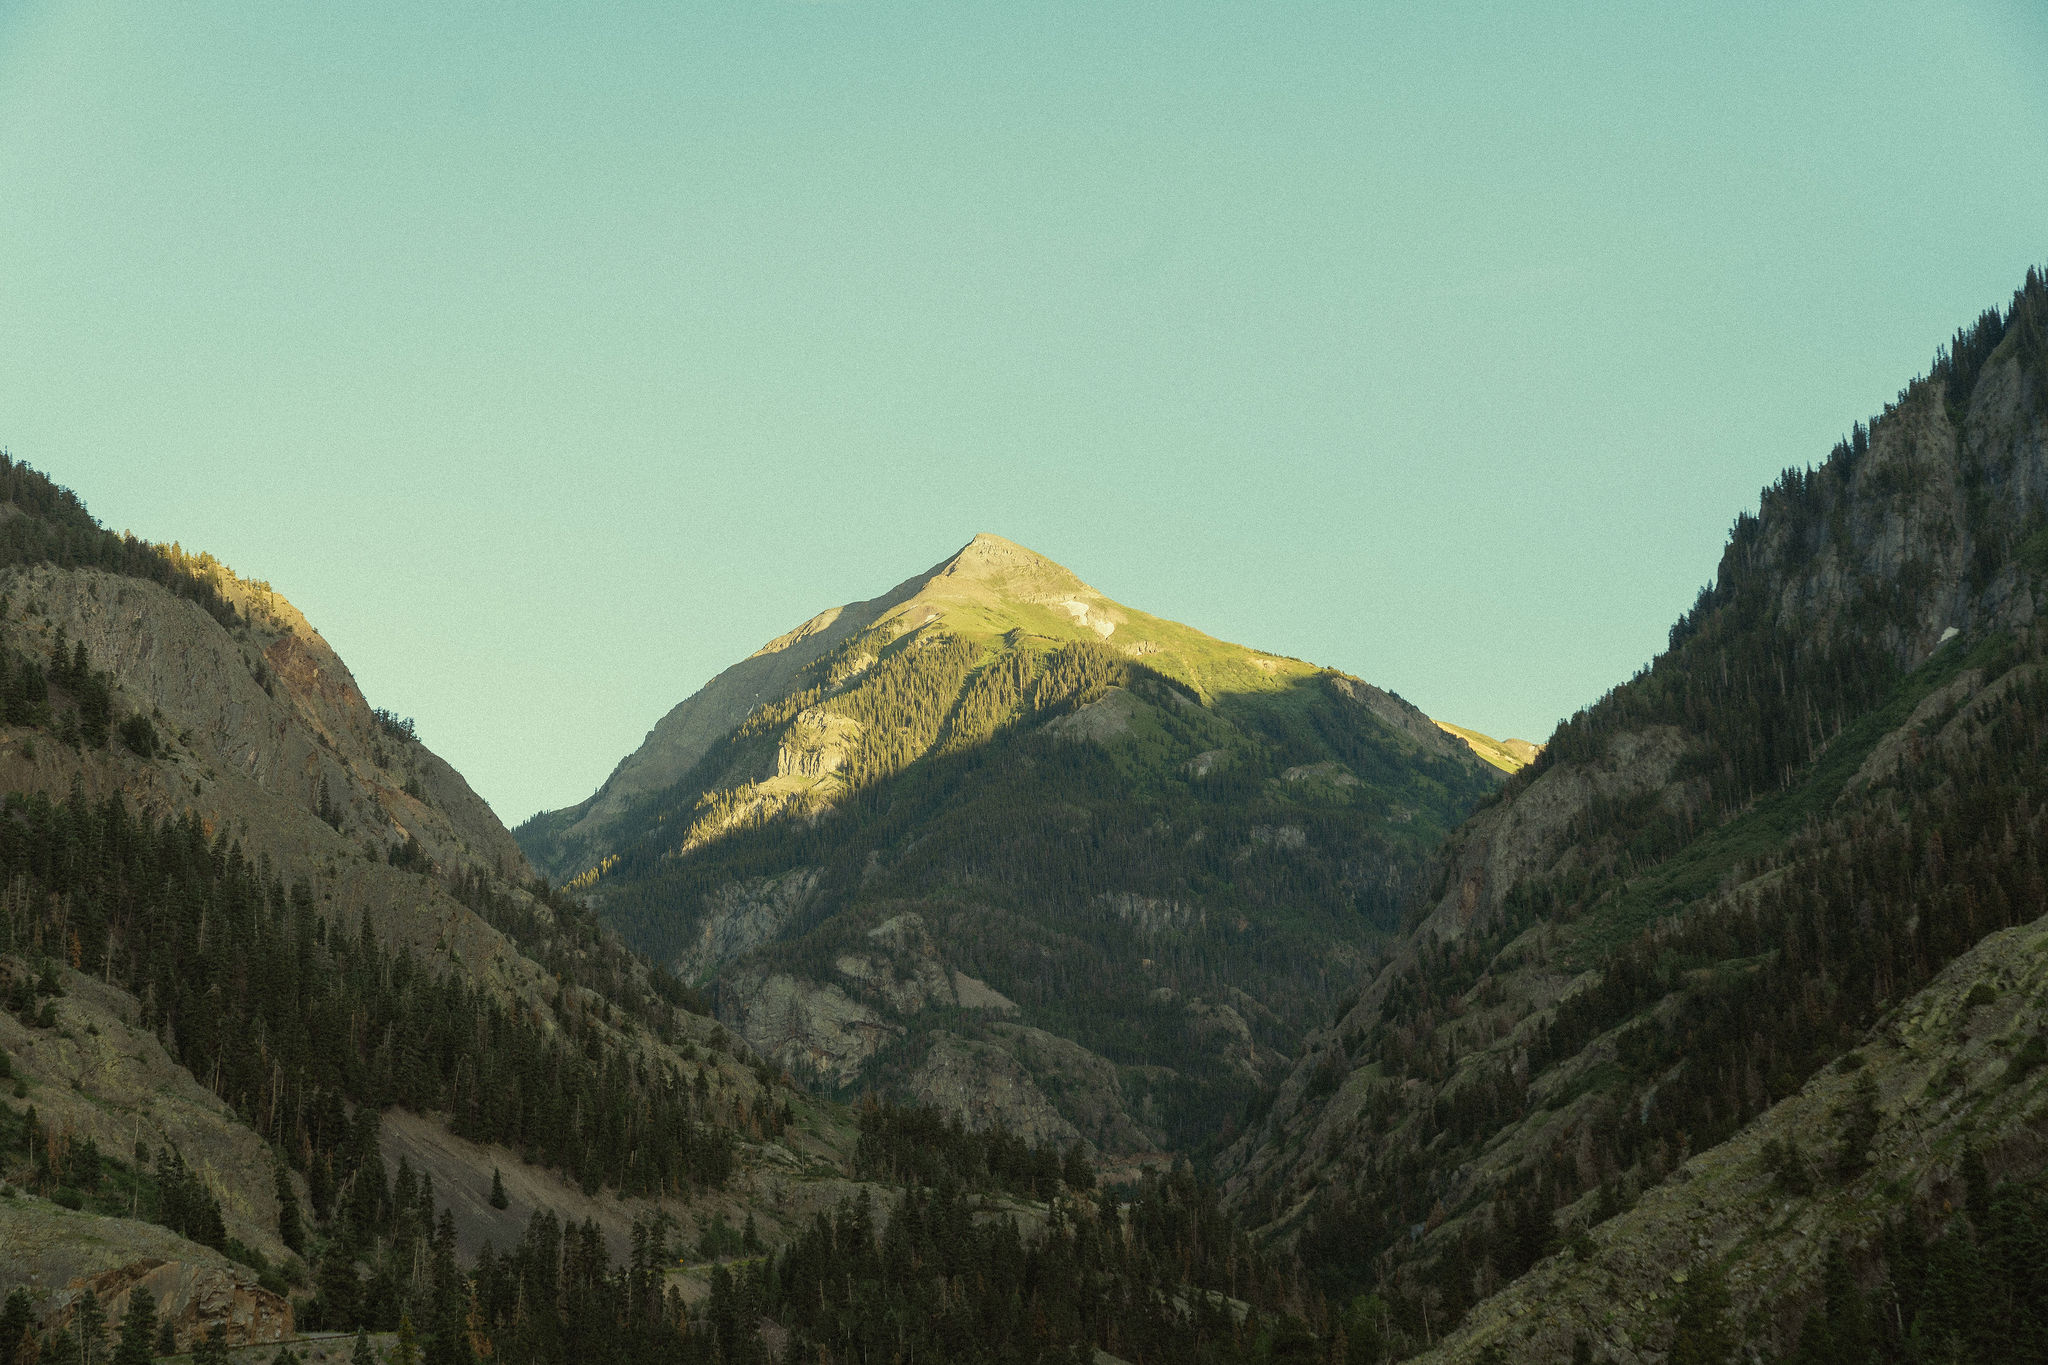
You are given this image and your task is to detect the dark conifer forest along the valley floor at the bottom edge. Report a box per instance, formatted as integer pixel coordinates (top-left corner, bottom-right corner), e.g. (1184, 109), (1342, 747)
(0, 1105), (1310, 1365)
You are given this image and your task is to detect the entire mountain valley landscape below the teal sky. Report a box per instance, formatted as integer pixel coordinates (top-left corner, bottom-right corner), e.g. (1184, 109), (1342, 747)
(0, 272), (2048, 1365)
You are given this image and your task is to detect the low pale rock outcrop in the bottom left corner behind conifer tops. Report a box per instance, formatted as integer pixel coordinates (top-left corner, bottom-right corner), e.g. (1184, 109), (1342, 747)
(0, 1195), (293, 1345)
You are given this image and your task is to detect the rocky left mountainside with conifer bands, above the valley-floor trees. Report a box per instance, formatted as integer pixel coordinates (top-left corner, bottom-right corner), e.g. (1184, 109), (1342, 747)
(0, 466), (888, 1359)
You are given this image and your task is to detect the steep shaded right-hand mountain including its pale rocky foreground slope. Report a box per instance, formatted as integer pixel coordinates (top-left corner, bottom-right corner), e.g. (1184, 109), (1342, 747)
(1221, 272), (2048, 1361)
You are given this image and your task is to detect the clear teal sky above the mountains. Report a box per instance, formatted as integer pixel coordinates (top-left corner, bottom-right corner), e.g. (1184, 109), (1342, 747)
(0, 0), (2048, 821)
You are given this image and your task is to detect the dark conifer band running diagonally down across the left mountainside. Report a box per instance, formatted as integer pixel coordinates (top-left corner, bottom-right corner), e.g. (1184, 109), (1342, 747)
(0, 792), (745, 1216)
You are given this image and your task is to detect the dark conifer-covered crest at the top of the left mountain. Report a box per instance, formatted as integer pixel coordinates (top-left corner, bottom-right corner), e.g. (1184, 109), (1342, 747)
(0, 450), (240, 626)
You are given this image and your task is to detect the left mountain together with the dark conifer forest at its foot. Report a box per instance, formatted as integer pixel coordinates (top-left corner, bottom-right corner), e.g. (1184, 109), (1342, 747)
(0, 454), (1343, 1365)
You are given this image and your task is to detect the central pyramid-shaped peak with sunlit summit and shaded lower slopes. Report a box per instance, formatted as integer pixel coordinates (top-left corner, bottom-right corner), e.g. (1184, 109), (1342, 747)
(516, 534), (1499, 1156)
